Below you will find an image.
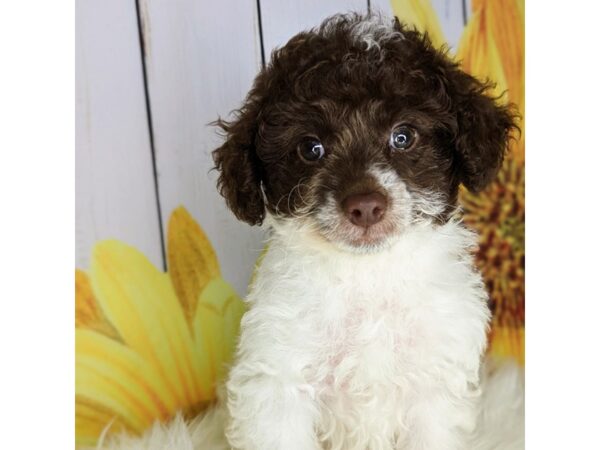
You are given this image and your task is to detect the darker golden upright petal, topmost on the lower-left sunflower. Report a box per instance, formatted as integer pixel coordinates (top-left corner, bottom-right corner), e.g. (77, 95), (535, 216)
(167, 206), (221, 323)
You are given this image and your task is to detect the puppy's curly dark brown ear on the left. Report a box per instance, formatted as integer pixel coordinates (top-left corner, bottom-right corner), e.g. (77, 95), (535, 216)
(212, 104), (265, 225)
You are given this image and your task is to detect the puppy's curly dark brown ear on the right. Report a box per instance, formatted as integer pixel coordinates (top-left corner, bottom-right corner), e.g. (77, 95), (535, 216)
(446, 67), (518, 192)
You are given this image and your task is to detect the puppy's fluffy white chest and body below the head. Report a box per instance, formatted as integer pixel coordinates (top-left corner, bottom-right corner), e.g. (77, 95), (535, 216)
(228, 222), (489, 449)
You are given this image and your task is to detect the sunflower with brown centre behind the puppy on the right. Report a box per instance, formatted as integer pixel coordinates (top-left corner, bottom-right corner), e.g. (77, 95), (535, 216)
(392, 0), (525, 363)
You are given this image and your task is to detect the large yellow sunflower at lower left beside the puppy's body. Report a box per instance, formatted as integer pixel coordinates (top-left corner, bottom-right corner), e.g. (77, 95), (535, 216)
(75, 207), (244, 445)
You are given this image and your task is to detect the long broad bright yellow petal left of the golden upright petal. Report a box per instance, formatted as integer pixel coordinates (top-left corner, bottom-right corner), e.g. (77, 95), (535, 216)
(90, 241), (204, 406)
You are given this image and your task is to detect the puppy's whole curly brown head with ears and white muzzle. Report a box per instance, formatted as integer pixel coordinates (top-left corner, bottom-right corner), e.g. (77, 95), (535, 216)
(213, 15), (515, 251)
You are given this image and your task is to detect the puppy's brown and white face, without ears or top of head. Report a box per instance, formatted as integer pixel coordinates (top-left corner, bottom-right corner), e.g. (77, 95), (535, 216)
(257, 97), (458, 251)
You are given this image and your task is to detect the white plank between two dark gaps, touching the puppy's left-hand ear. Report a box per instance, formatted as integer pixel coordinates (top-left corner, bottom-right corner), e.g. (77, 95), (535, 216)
(140, 0), (262, 294)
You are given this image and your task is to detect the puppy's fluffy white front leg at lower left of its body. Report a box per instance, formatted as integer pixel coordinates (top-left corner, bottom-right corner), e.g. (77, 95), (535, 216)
(226, 358), (320, 450)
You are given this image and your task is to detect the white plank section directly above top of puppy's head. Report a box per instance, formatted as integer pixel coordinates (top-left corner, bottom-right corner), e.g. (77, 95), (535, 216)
(260, 0), (367, 60)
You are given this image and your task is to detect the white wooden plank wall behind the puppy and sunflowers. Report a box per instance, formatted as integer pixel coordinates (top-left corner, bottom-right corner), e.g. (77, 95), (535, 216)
(76, 0), (470, 294)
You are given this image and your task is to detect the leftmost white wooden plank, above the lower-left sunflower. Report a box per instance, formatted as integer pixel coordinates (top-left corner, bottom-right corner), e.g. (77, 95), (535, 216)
(75, 0), (163, 268)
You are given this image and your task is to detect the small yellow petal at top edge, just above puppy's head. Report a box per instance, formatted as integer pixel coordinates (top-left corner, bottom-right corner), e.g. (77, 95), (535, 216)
(392, 0), (446, 48)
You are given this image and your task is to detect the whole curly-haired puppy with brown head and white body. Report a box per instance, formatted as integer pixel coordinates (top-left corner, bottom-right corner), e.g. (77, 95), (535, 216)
(213, 15), (515, 450)
